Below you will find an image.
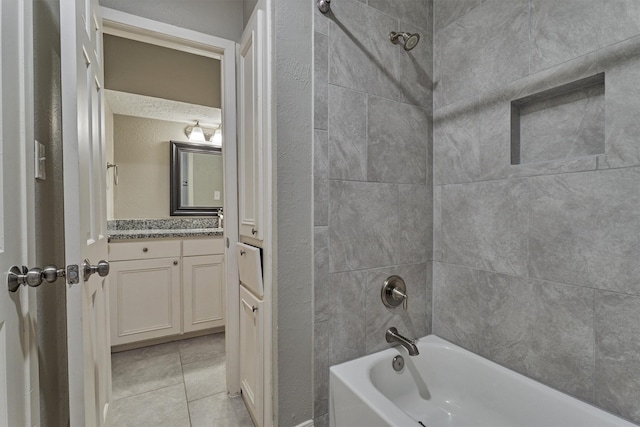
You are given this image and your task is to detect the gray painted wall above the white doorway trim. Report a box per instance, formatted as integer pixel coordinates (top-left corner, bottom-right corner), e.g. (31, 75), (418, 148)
(100, 0), (243, 41)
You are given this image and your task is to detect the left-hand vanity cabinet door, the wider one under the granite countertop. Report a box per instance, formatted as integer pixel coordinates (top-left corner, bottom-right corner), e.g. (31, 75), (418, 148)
(109, 257), (182, 345)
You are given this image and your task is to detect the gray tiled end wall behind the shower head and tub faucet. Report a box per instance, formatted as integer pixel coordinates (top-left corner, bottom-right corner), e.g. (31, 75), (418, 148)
(314, 0), (433, 426)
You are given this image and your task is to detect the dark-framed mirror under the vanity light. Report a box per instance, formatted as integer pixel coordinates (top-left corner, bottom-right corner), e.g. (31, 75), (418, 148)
(170, 141), (224, 216)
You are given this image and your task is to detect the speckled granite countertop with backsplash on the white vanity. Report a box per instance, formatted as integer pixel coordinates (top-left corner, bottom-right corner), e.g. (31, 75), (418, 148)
(107, 218), (224, 241)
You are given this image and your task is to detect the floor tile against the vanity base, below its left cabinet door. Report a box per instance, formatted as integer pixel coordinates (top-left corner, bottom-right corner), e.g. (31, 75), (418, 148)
(111, 353), (183, 400)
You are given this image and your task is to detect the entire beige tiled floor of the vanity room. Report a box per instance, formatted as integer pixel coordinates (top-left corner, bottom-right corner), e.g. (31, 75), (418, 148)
(111, 333), (253, 427)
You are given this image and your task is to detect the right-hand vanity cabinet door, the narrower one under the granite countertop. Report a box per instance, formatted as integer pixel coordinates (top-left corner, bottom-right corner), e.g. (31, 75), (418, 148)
(182, 255), (225, 332)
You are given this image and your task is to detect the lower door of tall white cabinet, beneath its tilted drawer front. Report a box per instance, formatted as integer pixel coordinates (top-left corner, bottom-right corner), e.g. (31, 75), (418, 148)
(240, 286), (264, 427)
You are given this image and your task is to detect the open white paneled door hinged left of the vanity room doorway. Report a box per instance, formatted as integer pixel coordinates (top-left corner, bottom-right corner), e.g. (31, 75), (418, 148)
(60, 0), (111, 427)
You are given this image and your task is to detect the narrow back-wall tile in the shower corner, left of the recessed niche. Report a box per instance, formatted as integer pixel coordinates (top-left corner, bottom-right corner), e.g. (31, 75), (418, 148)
(433, 96), (480, 185)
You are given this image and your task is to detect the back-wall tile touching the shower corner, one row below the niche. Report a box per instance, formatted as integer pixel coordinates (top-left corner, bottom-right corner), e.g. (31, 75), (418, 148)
(440, 180), (529, 276)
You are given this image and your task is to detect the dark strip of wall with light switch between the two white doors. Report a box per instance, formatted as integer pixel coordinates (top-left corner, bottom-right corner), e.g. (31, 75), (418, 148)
(33, 0), (69, 427)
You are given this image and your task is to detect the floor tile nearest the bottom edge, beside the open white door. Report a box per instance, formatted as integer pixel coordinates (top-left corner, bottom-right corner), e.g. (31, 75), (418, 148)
(113, 384), (190, 427)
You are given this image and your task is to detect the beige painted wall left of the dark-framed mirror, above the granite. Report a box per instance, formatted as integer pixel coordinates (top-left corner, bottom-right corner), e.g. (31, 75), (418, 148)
(113, 114), (187, 219)
